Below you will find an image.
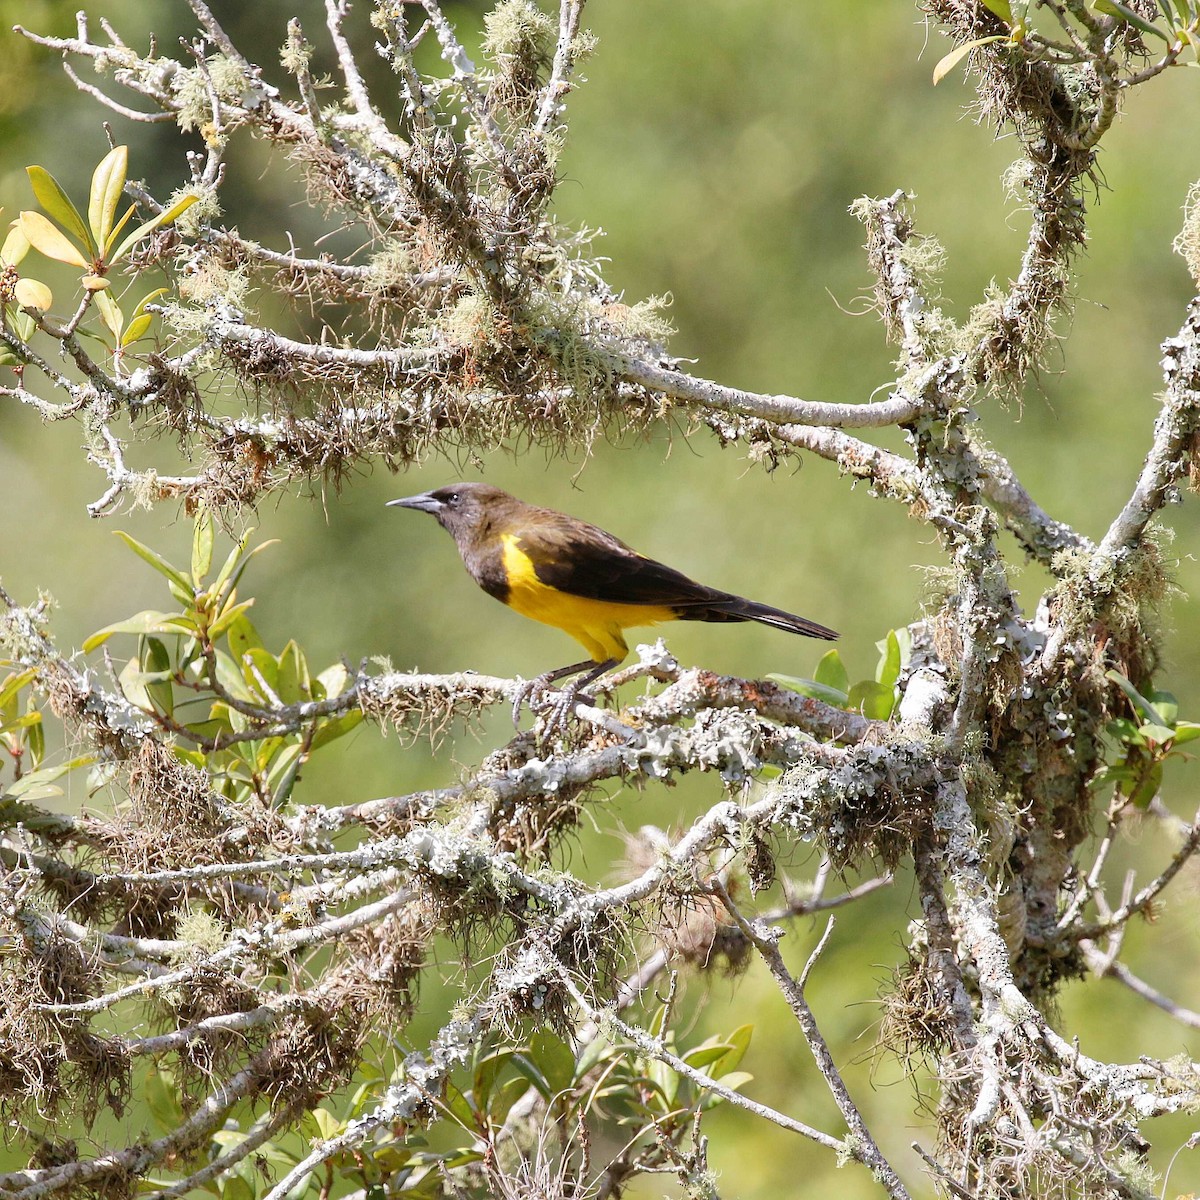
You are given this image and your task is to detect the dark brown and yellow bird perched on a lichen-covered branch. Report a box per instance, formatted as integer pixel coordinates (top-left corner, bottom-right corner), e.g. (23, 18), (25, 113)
(388, 482), (838, 725)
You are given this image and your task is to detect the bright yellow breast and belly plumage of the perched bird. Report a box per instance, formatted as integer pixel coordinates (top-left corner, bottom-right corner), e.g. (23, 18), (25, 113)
(500, 533), (676, 662)
